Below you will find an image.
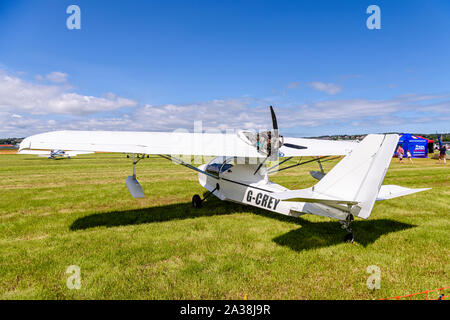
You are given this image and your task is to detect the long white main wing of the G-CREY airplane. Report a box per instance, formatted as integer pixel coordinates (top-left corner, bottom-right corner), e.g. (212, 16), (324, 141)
(19, 131), (356, 158)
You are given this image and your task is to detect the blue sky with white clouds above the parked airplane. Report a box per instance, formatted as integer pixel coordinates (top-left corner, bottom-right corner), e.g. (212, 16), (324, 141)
(0, 0), (450, 136)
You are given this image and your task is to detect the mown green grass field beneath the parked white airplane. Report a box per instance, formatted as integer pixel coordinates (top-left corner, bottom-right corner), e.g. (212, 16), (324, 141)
(0, 154), (450, 299)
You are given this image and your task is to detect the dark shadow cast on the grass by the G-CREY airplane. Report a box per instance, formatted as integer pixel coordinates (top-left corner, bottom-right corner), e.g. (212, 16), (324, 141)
(70, 199), (416, 251)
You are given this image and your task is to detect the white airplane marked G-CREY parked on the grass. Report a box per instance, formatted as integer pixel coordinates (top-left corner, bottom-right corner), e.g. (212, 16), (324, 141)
(20, 106), (429, 242)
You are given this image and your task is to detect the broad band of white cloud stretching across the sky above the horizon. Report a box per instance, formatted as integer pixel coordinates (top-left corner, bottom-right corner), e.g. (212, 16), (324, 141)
(0, 71), (450, 136)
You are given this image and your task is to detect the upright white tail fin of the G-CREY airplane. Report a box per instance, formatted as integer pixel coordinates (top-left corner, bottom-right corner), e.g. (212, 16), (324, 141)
(312, 134), (399, 219)
